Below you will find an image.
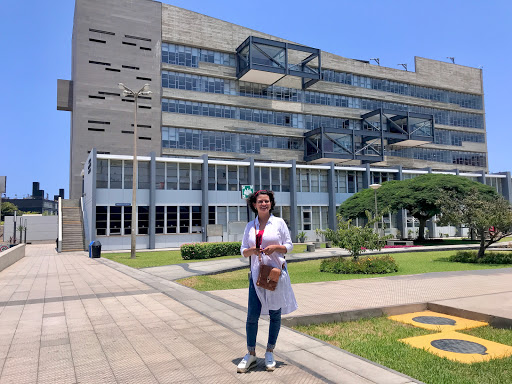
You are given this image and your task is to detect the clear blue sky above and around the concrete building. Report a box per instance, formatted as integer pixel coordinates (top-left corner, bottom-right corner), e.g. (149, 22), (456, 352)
(0, 0), (512, 197)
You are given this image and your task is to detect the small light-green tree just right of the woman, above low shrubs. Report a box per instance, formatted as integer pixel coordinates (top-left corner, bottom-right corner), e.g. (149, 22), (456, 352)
(322, 212), (391, 260)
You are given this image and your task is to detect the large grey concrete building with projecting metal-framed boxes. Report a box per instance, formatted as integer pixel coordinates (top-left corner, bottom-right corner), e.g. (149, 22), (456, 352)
(57, 0), (510, 248)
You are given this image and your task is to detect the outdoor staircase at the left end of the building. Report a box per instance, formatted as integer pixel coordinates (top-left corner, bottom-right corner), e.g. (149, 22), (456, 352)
(62, 199), (86, 252)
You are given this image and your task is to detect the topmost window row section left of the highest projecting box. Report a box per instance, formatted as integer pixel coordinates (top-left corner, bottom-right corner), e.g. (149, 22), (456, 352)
(162, 43), (236, 68)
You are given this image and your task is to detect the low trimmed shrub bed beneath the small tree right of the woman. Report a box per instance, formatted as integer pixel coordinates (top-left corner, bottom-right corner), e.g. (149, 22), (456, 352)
(320, 255), (398, 274)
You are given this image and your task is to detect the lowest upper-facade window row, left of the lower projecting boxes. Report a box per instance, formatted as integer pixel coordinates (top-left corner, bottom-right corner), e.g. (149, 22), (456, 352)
(162, 127), (304, 154)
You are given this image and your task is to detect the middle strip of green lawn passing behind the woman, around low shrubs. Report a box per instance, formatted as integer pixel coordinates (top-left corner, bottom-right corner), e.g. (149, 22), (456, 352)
(178, 251), (512, 291)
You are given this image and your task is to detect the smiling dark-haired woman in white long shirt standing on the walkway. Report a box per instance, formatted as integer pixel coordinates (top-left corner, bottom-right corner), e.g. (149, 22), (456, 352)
(237, 190), (297, 373)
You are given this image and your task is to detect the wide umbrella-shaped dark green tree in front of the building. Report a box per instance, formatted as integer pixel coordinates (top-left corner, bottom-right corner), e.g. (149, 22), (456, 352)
(339, 174), (498, 241)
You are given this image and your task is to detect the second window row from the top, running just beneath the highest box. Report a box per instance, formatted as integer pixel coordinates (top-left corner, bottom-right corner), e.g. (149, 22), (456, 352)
(162, 71), (484, 129)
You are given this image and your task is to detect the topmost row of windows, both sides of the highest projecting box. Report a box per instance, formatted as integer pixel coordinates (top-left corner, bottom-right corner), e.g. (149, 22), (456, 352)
(162, 43), (483, 109)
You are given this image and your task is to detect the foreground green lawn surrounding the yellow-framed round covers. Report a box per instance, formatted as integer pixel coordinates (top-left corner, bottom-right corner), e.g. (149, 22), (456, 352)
(294, 317), (512, 384)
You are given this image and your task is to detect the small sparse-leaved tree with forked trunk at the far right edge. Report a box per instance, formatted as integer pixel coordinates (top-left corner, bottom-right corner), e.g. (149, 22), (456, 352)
(440, 190), (512, 258)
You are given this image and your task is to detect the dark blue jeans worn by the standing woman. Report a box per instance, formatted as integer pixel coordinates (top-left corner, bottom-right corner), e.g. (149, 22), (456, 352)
(245, 278), (281, 352)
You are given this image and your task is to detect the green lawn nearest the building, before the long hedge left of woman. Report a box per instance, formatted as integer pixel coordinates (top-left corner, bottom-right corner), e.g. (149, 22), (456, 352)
(101, 244), (306, 268)
